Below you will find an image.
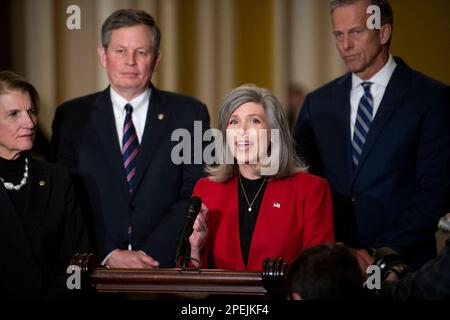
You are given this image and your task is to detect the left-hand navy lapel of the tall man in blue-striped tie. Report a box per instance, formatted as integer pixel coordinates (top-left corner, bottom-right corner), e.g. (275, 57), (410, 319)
(330, 73), (353, 190)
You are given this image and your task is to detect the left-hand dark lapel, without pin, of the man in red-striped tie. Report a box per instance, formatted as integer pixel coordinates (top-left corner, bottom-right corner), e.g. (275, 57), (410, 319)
(91, 87), (129, 197)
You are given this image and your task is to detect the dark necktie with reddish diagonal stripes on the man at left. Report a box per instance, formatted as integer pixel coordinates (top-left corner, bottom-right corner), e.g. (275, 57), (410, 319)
(122, 104), (139, 193)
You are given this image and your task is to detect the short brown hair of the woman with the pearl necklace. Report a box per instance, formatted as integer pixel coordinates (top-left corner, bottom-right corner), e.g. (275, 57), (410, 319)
(0, 70), (39, 113)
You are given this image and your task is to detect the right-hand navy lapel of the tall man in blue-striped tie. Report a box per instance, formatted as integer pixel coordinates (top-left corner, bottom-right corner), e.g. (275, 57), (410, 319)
(353, 59), (410, 182)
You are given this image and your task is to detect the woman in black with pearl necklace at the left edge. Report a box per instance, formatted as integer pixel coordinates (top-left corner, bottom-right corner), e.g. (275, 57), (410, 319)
(0, 71), (88, 299)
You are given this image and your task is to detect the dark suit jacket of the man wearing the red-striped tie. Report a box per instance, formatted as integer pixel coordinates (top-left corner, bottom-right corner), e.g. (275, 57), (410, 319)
(52, 87), (209, 267)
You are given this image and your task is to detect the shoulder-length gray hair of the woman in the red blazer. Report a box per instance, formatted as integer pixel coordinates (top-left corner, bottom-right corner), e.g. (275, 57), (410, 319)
(206, 84), (307, 182)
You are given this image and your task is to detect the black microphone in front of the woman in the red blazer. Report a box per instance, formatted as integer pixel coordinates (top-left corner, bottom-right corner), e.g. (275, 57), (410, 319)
(175, 197), (202, 268)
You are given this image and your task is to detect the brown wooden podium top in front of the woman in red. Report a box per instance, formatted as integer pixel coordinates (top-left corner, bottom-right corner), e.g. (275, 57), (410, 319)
(70, 254), (287, 298)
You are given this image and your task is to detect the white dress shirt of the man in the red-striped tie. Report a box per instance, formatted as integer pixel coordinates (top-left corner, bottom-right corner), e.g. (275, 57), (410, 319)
(110, 87), (151, 148)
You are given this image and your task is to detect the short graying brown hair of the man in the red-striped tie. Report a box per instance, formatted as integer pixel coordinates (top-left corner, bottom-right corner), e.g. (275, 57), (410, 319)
(102, 9), (161, 54)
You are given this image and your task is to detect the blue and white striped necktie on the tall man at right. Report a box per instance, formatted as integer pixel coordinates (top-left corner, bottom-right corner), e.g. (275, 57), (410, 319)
(352, 82), (373, 168)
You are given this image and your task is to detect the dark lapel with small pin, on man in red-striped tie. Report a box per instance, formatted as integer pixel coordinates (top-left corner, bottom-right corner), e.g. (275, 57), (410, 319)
(132, 87), (171, 196)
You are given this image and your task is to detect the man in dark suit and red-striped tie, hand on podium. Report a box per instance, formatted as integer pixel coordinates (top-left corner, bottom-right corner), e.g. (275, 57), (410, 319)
(52, 10), (209, 268)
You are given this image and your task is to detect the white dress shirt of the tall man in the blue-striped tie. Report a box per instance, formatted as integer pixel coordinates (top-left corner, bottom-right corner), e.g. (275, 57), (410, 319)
(350, 55), (397, 139)
